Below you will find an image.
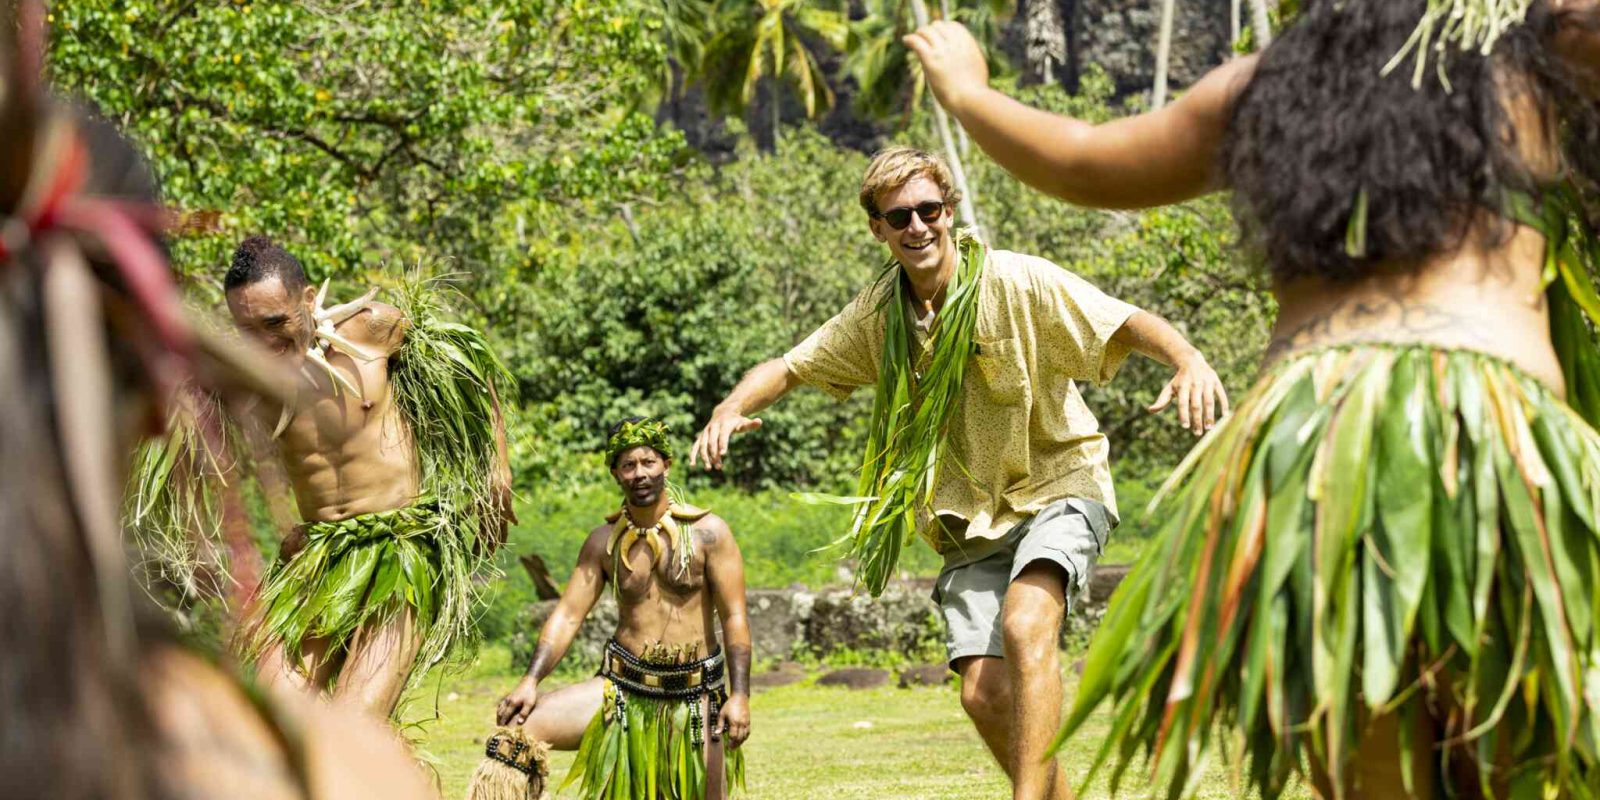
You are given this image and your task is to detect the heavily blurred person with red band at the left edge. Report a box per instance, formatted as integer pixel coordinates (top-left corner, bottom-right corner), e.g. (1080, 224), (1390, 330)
(0, 3), (429, 800)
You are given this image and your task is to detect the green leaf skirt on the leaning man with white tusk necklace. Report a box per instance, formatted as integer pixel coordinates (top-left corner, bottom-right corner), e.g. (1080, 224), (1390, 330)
(246, 499), (470, 669)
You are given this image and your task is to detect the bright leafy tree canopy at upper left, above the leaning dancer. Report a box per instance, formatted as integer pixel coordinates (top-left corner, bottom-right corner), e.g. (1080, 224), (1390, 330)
(50, 0), (678, 294)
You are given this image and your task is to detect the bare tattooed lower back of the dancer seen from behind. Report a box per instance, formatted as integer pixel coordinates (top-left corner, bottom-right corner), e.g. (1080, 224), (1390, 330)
(1264, 78), (1565, 395)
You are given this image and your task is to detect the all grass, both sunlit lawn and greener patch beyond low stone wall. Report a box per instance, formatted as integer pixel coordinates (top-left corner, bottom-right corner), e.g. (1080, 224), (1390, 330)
(435, 480), (1307, 800)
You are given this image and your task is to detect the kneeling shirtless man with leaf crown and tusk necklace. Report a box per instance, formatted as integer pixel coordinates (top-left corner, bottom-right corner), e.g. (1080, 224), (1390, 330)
(467, 419), (750, 800)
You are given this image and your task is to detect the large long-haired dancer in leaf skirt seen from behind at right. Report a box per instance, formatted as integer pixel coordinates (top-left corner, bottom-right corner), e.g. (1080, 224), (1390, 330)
(907, 0), (1600, 798)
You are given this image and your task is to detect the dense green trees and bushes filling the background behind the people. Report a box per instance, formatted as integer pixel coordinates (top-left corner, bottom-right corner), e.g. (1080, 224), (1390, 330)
(62, 0), (1272, 594)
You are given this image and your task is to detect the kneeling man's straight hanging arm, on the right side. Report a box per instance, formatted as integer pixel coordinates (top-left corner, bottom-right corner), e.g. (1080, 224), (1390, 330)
(706, 518), (750, 749)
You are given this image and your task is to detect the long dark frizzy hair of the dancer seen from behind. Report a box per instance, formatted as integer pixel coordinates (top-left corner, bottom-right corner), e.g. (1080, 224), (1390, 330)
(1222, 0), (1600, 283)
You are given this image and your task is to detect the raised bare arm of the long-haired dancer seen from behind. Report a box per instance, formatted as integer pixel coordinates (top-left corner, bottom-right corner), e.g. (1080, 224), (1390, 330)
(906, 21), (1256, 208)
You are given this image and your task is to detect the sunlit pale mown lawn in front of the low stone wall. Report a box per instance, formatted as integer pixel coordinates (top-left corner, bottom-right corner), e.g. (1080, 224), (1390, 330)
(406, 650), (1307, 800)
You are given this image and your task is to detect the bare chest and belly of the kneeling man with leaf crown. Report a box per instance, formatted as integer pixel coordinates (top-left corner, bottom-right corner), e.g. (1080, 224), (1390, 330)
(605, 517), (717, 656)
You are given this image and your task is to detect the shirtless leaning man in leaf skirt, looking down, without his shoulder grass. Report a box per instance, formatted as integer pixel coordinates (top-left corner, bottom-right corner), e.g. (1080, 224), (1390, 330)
(224, 237), (510, 715)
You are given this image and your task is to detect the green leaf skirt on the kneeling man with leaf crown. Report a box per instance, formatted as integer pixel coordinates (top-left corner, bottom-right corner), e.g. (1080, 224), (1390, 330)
(562, 658), (744, 800)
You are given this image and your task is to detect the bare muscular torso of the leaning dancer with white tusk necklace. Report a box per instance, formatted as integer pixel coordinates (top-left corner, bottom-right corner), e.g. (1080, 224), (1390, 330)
(269, 314), (418, 522)
